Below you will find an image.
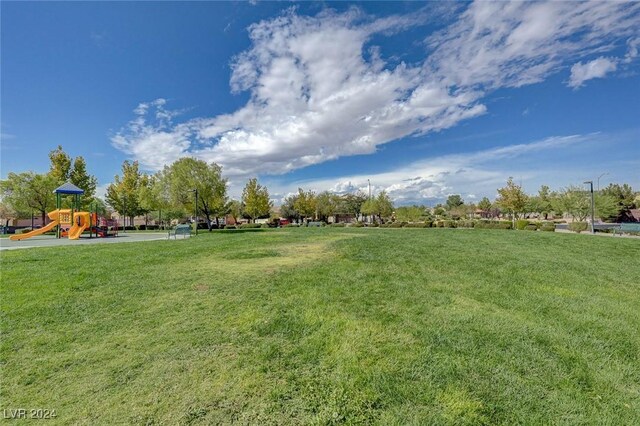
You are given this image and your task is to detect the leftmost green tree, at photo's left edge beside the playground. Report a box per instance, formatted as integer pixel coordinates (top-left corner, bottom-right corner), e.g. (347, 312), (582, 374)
(0, 172), (58, 224)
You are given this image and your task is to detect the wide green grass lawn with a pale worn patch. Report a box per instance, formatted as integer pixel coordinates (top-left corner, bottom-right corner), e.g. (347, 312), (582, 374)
(0, 228), (640, 425)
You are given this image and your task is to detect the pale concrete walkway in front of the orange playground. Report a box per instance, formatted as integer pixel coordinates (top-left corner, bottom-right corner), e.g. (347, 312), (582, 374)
(0, 232), (172, 250)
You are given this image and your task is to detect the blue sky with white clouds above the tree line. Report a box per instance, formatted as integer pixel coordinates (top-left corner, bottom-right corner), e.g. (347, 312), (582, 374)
(0, 2), (640, 204)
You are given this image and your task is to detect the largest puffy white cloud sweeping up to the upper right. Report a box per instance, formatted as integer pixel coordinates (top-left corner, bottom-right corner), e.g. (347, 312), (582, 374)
(112, 2), (640, 177)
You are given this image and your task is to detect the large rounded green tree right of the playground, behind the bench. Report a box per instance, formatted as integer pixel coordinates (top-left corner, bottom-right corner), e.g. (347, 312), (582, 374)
(164, 157), (227, 231)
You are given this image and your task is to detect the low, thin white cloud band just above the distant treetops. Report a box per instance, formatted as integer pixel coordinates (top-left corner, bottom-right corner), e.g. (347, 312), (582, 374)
(267, 134), (602, 204)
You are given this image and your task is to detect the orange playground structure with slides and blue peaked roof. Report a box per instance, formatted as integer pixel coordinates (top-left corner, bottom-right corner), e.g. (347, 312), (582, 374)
(10, 183), (118, 241)
